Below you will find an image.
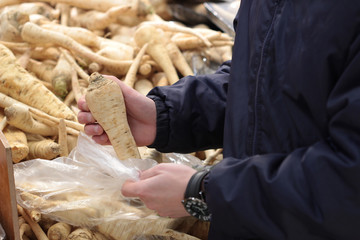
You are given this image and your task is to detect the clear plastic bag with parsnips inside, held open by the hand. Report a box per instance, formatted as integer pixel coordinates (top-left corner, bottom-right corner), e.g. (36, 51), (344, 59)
(14, 133), (205, 239)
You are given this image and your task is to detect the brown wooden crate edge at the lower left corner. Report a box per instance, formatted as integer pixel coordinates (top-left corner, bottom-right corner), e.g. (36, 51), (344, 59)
(0, 131), (20, 240)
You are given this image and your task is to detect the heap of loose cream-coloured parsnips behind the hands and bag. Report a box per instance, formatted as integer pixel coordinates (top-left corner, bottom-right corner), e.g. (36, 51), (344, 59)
(0, 0), (233, 240)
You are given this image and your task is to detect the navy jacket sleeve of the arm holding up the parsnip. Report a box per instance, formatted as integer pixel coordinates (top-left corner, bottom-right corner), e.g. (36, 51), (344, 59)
(147, 61), (230, 153)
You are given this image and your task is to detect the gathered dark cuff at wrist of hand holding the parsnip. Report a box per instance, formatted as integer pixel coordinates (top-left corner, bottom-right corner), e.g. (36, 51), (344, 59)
(147, 95), (170, 149)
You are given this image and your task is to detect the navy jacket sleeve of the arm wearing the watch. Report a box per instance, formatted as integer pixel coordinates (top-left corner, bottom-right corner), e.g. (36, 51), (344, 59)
(205, 36), (360, 240)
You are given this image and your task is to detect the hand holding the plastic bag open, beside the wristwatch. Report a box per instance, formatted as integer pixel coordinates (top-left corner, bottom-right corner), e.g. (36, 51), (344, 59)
(122, 163), (196, 218)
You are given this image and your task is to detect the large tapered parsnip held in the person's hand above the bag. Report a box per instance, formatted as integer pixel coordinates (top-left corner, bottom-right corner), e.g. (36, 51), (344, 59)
(85, 73), (140, 160)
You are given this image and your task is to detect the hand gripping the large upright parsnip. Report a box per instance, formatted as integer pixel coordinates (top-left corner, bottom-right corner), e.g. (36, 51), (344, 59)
(78, 76), (156, 146)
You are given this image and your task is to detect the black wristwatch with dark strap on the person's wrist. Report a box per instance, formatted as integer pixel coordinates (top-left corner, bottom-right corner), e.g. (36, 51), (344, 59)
(182, 169), (211, 221)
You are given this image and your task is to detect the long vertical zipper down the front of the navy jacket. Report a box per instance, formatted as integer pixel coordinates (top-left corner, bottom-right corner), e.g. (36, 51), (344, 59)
(251, 0), (280, 155)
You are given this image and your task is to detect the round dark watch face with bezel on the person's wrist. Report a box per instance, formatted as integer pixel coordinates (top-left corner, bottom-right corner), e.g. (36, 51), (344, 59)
(182, 197), (211, 221)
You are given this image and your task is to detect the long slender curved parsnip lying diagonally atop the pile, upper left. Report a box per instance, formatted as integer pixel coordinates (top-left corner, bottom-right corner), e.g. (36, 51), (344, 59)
(21, 22), (132, 75)
